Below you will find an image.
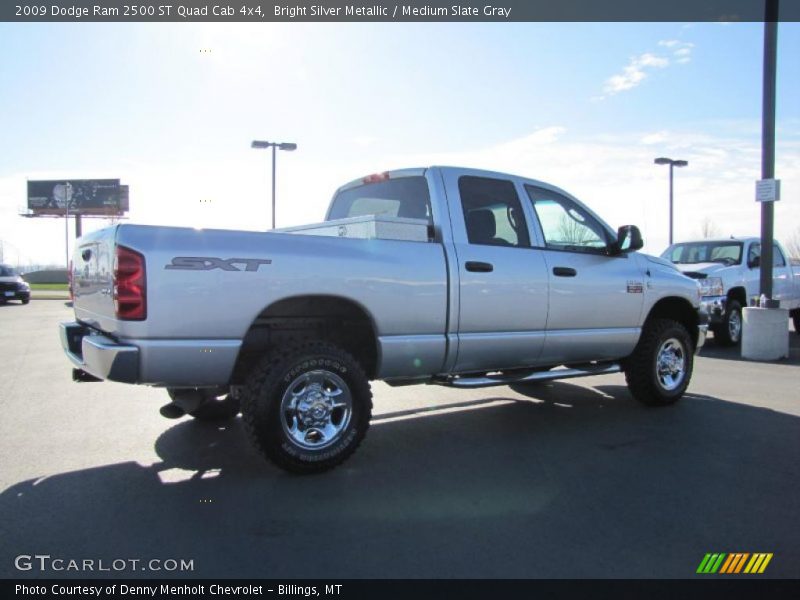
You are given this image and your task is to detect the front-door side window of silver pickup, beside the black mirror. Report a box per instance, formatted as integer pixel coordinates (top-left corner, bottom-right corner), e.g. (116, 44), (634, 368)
(525, 185), (609, 253)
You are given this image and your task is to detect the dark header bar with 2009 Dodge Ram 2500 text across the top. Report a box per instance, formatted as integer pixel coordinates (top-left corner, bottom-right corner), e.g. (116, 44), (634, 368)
(0, 0), (800, 23)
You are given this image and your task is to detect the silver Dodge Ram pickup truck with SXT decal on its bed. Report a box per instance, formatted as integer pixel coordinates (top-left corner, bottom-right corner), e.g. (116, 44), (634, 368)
(61, 167), (707, 473)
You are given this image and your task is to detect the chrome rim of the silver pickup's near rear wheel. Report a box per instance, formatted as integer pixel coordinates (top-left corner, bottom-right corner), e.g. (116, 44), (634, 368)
(281, 370), (353, 450)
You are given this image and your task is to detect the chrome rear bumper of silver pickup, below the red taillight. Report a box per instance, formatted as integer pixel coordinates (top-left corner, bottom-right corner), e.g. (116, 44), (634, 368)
(59, 322), (139, 383)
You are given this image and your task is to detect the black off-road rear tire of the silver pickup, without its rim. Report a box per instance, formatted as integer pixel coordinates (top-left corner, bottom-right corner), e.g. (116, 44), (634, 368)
(241, 341), (372, 474)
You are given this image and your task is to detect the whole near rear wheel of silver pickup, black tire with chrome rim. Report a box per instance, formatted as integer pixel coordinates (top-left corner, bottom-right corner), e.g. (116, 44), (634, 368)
(242, 342), (372, 473)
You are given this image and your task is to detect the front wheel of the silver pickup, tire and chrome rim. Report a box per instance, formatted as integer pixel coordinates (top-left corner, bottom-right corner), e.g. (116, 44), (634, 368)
(623, 319), (694, 406)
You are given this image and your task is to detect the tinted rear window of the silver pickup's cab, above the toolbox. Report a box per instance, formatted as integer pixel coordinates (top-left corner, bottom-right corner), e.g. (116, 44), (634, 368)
(328, 177), (431, 223)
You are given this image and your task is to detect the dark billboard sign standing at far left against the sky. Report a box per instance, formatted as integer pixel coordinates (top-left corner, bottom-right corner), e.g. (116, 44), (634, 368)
(28, 179), (128, 216)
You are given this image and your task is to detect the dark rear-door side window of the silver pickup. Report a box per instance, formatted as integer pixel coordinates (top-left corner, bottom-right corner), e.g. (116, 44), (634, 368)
(458, 175), (530, 248)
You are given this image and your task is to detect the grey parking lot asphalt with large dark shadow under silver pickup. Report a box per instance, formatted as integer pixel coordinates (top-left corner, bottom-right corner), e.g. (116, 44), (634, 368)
(0, 300), (800, 579)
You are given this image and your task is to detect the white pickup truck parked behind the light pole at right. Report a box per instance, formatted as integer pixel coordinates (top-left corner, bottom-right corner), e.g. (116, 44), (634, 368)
(661, 237), (800, 346)
